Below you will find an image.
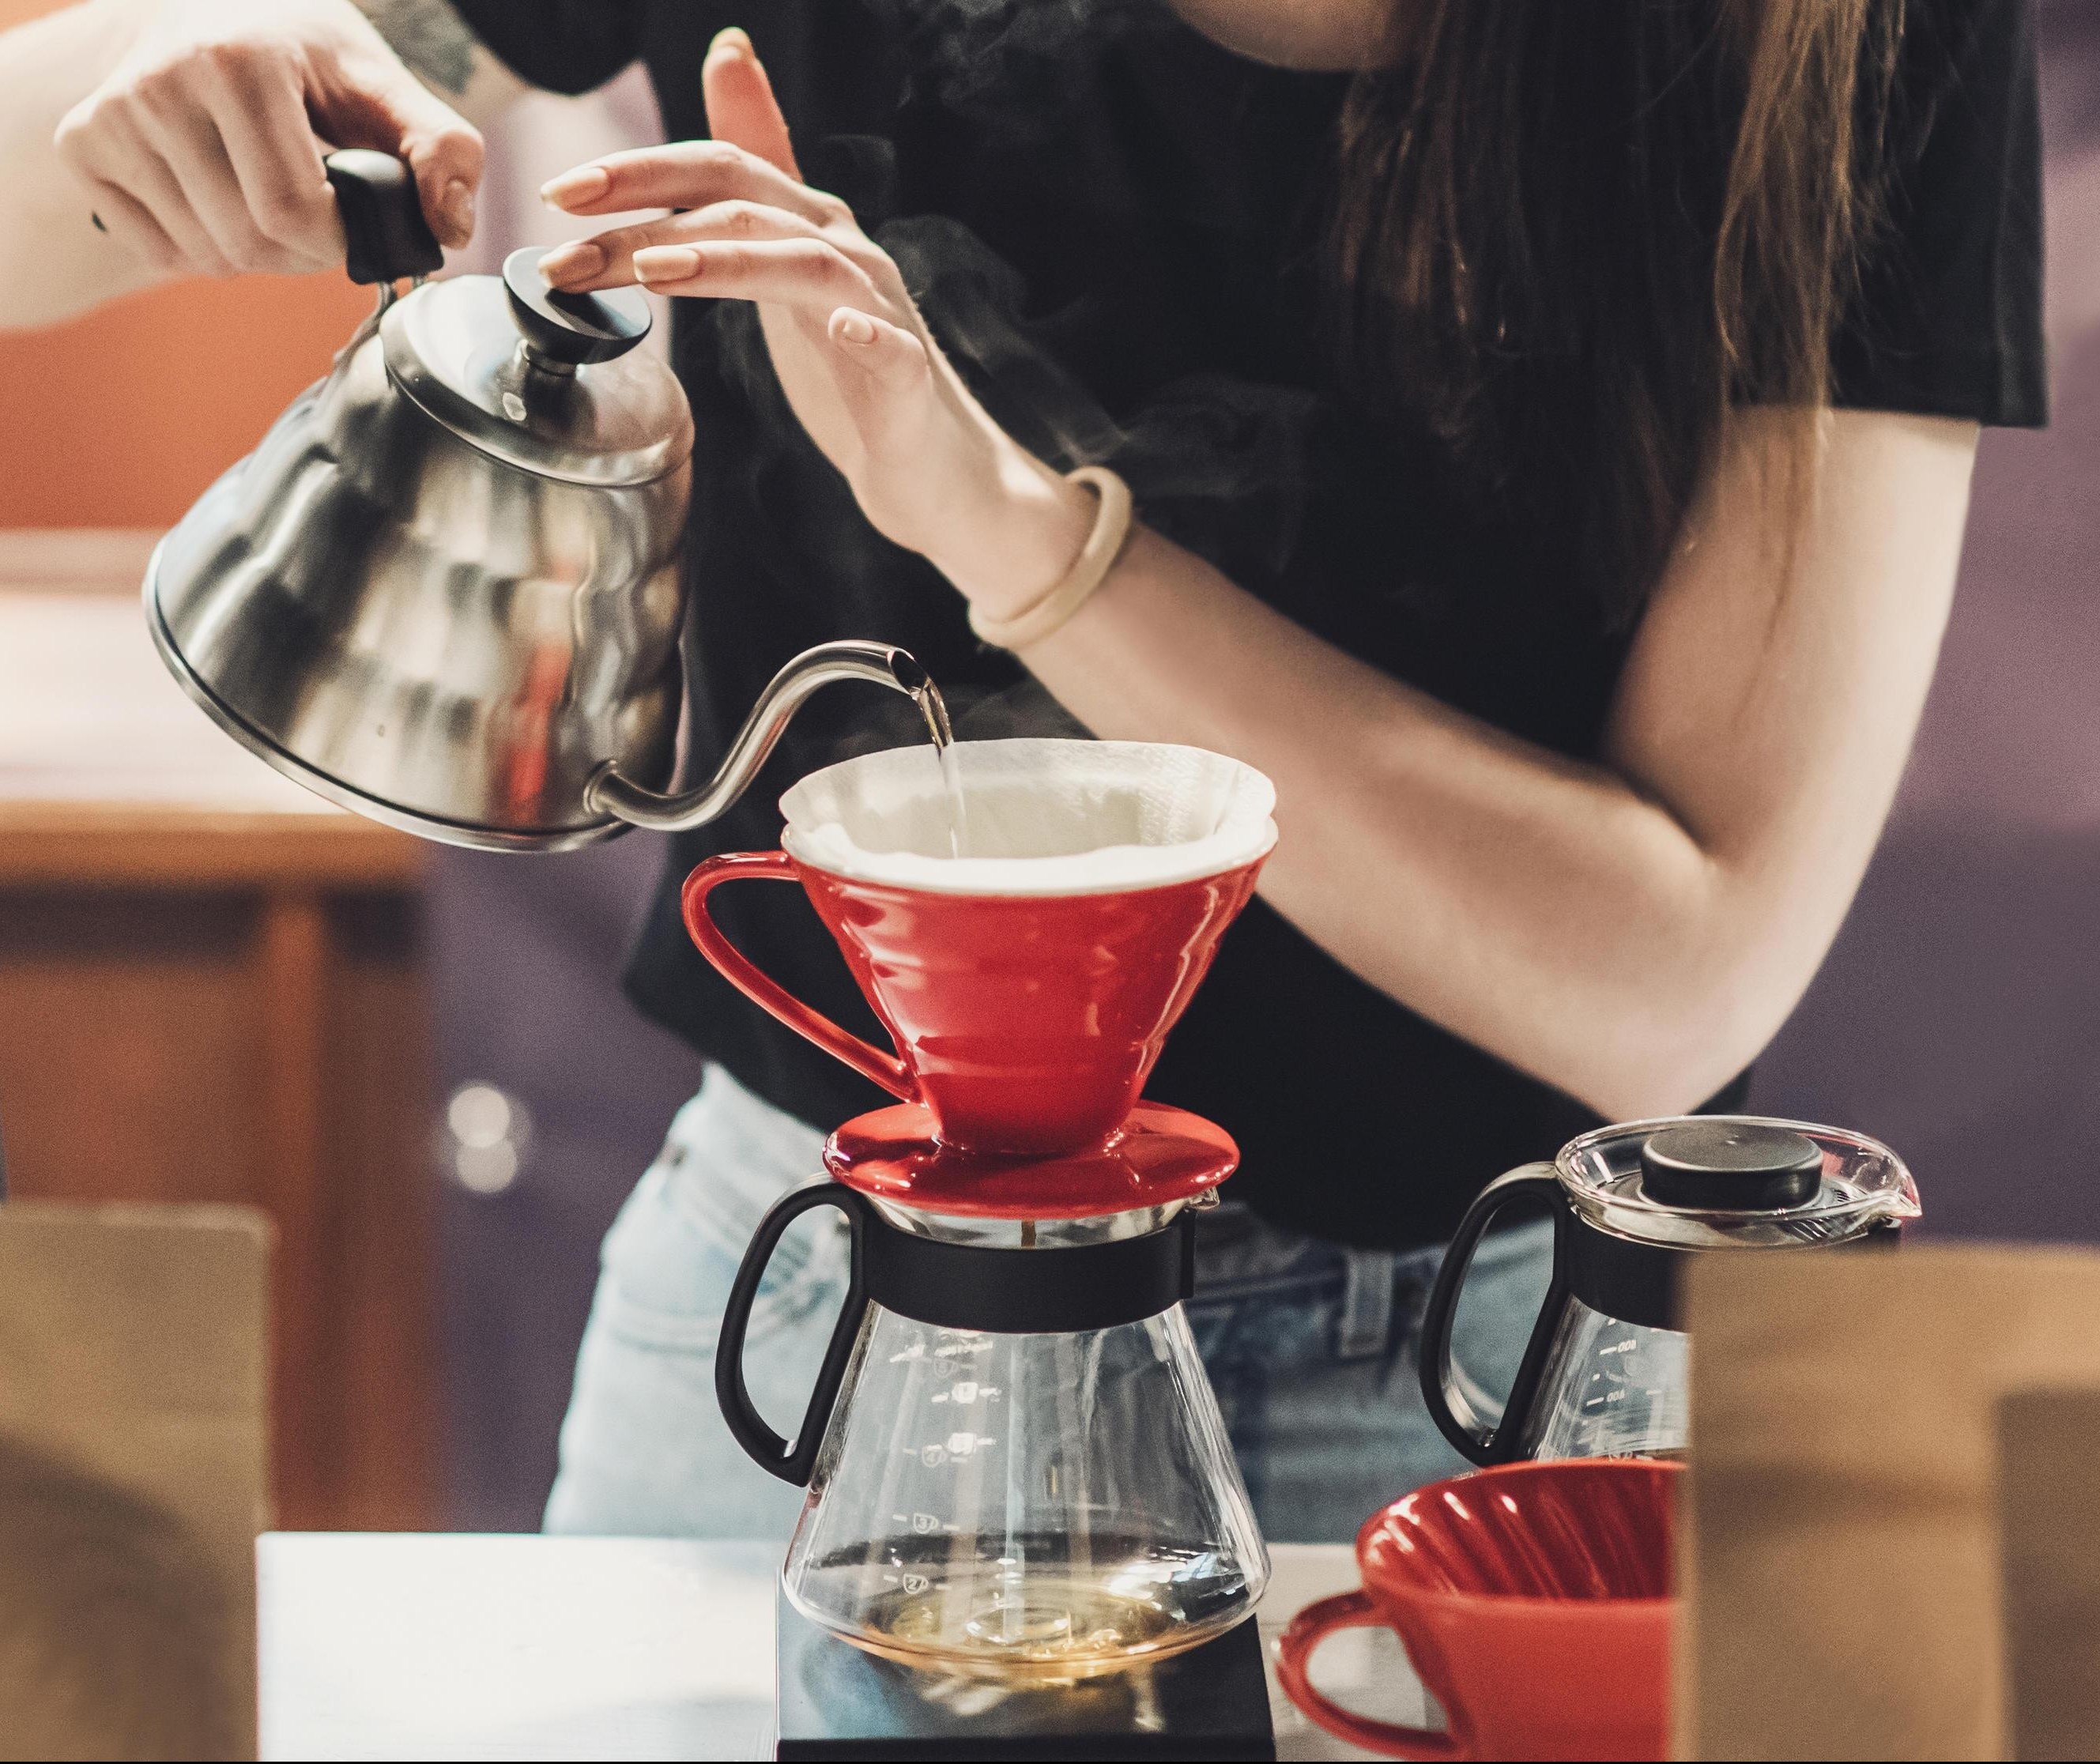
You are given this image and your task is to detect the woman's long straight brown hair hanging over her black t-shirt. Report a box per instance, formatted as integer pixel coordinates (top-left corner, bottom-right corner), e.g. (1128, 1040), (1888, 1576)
(1333, 0), (1902, 622)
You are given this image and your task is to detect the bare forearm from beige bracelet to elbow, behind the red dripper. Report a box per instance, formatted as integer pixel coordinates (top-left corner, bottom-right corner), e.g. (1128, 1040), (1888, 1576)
(1027, 530), (1732, 1113)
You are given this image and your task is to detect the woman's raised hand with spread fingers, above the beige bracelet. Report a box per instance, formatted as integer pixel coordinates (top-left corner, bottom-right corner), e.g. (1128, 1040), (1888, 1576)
(542, 32), (1094, 616)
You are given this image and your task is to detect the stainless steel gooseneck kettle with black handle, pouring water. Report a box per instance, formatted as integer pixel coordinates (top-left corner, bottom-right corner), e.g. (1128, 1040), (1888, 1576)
(145, 149), (947, 850)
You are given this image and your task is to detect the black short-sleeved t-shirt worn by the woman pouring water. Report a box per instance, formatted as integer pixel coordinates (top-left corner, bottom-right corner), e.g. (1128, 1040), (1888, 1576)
(456, 0), (2045, 1247)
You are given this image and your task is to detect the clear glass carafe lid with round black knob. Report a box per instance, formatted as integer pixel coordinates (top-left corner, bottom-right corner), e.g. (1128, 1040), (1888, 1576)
(1554, 1115), (1919, 1250)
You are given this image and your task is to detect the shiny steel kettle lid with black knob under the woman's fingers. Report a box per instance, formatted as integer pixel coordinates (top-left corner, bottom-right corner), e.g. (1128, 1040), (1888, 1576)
(380, 246), (693, 489)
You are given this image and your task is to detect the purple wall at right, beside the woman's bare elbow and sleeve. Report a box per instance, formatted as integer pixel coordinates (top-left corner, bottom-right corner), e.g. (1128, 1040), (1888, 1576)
(1751, 0), (2100, 1241)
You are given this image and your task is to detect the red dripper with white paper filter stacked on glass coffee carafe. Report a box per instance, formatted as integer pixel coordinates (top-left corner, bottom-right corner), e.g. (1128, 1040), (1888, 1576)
(684, 741), (1275, 1680)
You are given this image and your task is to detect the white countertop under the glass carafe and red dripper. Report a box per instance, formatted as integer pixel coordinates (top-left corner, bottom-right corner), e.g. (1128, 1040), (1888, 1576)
(256, 1531), (1419, 1760)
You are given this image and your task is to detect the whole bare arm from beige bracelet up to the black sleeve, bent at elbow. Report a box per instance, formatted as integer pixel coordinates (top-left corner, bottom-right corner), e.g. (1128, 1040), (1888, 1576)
(1008, 412), (1976, 1118)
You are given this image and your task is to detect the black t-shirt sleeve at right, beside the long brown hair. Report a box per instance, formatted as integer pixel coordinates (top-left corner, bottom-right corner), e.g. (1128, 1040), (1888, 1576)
(1834, 0), (2049, 428)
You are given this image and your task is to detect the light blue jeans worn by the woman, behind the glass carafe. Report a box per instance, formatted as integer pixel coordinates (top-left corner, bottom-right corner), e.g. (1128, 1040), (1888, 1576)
(546, 1067), (1552, 1544)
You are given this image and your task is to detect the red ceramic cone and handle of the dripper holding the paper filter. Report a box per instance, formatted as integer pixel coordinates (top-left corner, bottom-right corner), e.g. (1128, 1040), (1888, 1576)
(684, 850), (1262, 1157)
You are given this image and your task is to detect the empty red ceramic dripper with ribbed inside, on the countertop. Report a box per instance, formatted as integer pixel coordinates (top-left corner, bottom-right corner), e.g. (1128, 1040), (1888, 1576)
(1276, 1457), (1682, 1758)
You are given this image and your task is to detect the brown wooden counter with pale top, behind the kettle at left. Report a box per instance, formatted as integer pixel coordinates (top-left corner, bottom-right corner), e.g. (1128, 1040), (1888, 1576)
(0, 531), (437, 1528)
